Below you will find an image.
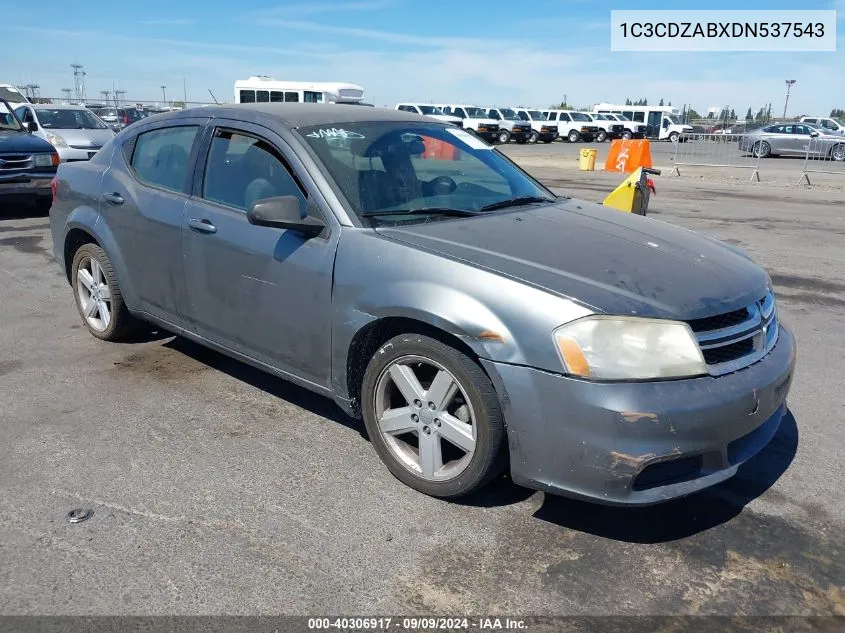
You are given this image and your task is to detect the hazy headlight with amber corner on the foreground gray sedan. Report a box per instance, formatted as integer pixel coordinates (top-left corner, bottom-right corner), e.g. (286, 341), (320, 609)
(554, 316), (707, 380)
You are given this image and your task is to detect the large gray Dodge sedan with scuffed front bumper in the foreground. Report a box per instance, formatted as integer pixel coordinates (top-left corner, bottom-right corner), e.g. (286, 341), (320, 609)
(50, 103), (795, 505)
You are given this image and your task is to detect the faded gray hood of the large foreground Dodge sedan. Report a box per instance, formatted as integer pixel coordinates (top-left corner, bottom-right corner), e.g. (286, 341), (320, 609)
(376, 200), (770, 320)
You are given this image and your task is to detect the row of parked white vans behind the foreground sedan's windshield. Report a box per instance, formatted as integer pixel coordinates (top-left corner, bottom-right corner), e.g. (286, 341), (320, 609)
(394, 102), (646, 144)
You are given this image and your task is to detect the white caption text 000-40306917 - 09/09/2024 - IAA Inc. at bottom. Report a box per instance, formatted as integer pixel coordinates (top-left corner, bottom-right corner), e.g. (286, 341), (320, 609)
(308, 617), (526, 633)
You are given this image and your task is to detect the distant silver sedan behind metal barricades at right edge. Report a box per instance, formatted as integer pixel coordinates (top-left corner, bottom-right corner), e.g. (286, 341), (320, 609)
(739, 123), (845, 160)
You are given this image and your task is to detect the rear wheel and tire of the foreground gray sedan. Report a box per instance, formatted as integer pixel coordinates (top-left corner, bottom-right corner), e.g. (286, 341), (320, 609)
(71, 243), (140, 341)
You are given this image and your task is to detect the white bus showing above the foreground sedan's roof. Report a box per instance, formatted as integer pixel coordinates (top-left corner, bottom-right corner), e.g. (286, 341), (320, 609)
(235, 75), (366, 105)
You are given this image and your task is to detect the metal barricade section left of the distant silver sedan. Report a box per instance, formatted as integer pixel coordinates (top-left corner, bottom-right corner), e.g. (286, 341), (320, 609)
(670, 133), (760, 182)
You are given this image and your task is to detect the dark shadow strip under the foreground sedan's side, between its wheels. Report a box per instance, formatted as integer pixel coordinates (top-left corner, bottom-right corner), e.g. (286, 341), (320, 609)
(162, 333), (369, 441)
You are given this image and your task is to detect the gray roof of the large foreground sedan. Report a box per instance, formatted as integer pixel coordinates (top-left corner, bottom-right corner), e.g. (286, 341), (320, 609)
(152, 103), (431, 129)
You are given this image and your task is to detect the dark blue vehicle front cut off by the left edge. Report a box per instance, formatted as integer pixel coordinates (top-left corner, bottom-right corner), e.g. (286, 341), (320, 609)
(0, 99), (60, 212)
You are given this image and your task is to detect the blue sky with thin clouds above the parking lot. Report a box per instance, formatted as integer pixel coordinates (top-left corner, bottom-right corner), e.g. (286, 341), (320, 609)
(0, 0), (845, 114)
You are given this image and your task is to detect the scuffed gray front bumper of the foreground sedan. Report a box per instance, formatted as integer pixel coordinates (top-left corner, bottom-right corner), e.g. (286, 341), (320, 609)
(482, 324), (795, 505)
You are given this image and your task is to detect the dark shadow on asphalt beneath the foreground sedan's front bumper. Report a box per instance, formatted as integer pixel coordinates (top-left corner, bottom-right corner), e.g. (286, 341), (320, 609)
(534, 411), (798, 544)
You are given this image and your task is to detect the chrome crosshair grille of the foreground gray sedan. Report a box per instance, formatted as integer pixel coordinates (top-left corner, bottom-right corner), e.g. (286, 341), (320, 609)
(687, 292), (778, 376)
